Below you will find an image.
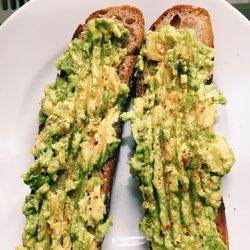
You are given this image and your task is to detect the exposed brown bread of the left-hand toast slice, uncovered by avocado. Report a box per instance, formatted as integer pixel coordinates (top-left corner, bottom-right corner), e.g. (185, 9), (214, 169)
(17, 5), (144, 249)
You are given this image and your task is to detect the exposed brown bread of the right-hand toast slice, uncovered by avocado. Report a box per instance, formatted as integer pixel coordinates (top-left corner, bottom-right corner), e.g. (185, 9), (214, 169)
(136, 5), (229, 246)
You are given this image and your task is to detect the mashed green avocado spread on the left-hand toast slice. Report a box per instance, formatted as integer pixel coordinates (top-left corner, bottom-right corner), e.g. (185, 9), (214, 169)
(17, 18), (129, 250)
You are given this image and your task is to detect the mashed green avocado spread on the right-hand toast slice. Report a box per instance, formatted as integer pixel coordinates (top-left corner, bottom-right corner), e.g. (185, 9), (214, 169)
(122, 25), (234, 250)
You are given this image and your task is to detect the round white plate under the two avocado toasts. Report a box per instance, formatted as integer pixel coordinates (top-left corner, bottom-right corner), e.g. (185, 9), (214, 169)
(0, 0), (250, 250)
